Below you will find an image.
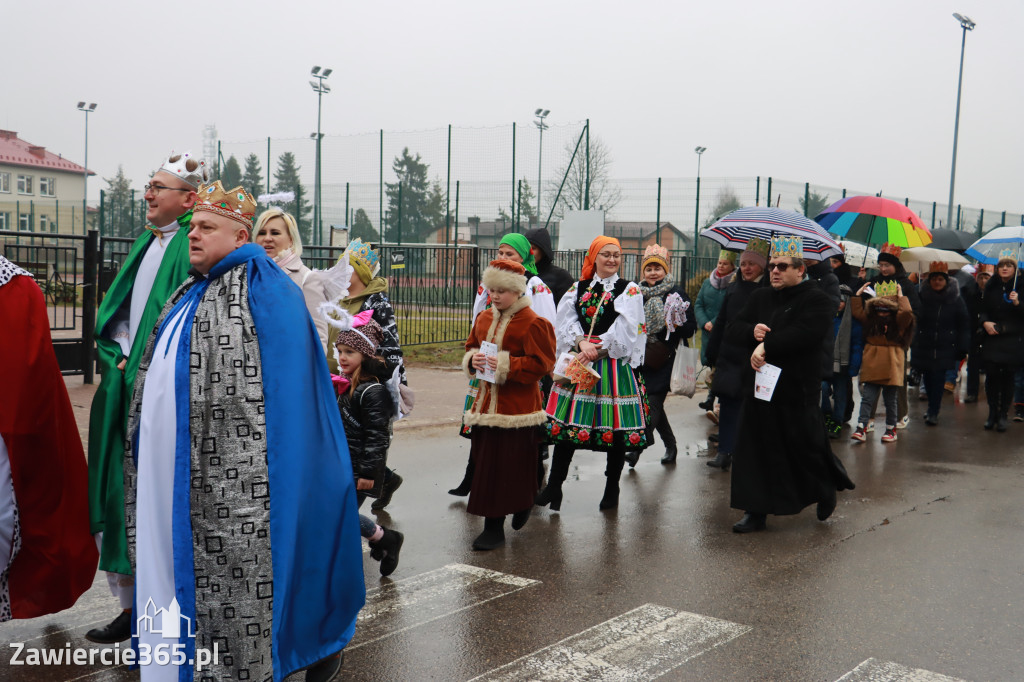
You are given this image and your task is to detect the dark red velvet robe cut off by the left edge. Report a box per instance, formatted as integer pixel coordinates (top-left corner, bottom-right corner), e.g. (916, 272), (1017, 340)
(0, 275), (99, 619)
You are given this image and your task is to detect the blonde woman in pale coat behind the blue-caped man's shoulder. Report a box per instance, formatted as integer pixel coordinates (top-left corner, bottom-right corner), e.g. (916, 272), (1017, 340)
(252, 208), (330, 352)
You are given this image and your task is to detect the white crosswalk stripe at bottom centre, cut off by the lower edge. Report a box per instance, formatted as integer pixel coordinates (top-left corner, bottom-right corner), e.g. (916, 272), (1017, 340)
(474, 604), (751, 682)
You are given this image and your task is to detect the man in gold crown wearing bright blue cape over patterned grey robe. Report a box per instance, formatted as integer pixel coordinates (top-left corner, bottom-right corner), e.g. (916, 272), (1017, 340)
(123, 181), (366, 682)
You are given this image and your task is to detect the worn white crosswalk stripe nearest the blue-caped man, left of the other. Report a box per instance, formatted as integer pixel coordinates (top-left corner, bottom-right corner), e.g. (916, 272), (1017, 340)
(347, 563), (541, 649)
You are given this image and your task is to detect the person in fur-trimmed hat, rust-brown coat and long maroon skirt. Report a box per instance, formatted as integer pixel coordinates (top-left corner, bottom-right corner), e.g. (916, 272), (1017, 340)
(462, 260), (555, 550)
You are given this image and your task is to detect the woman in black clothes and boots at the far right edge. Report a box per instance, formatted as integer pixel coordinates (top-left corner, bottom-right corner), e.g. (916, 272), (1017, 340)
(981, 258), (1024, 431)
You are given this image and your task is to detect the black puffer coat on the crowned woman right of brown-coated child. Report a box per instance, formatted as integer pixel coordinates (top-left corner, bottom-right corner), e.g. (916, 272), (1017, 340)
(910, 281), (971, 372)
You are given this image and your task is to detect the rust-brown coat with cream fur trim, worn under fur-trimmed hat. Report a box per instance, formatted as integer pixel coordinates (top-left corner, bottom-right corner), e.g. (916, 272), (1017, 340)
(462, 296), (555, 429)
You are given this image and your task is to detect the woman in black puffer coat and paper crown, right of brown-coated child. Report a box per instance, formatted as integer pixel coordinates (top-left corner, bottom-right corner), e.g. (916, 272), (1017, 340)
(910, 263), (971, 426)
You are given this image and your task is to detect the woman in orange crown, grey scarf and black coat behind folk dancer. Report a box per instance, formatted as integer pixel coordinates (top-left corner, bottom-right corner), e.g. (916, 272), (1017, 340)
(626, 244), (697, 467)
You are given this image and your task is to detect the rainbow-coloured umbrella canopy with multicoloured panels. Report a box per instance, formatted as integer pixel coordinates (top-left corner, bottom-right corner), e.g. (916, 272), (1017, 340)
(815, 197), (932, 249)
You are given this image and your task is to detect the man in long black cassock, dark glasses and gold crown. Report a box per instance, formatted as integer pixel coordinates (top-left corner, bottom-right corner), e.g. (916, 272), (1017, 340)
(726, 237), (853, 532)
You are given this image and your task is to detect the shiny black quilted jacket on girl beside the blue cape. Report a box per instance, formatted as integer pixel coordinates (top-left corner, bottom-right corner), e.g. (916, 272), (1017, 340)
(338, 358), (394, 498)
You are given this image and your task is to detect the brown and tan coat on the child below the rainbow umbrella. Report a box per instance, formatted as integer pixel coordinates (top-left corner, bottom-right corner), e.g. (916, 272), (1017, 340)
(850, 296), (914, 386)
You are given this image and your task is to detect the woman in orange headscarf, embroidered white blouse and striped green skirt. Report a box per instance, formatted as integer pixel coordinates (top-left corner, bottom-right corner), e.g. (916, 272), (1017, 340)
(537, 237), (647, 510)
